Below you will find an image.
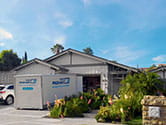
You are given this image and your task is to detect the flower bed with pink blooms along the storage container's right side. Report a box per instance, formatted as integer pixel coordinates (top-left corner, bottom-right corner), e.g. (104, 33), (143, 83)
(47, 89), (110, 118)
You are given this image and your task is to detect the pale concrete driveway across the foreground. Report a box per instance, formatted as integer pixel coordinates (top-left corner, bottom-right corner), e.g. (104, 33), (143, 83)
(0, 104), (122, 125)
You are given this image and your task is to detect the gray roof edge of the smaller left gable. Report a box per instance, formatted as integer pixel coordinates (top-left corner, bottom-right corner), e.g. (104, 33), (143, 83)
(13, 58), (68, 71)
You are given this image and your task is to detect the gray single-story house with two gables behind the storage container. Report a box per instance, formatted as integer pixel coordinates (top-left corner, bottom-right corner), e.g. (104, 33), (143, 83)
(13, 49), (138, 94)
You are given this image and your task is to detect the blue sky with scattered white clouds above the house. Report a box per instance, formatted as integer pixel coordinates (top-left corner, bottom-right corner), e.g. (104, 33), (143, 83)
(0, 0), (166, 67)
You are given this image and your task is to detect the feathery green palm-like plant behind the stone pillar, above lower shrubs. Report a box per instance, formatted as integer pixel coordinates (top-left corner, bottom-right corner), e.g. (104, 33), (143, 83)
(120, 72), (162, 95)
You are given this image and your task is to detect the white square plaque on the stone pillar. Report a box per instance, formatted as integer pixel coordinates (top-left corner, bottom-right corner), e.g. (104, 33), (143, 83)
(148, 106), (160, 118)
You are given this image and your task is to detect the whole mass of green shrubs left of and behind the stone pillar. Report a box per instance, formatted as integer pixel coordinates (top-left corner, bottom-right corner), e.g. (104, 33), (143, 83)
(96, 73), (161, 122)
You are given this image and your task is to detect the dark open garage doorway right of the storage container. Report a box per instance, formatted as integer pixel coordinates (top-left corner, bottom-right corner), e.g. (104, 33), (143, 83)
(83, 75), (100, 92)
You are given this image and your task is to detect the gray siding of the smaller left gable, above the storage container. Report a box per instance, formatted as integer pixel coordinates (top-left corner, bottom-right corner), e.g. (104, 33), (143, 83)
(16, 63), (55, 75)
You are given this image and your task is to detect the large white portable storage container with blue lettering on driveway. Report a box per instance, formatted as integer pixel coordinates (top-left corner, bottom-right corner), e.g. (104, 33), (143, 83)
(15, 74), (82, 109)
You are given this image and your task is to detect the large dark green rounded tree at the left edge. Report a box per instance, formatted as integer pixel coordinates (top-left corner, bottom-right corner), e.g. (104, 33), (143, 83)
(0, 49), (21, 71)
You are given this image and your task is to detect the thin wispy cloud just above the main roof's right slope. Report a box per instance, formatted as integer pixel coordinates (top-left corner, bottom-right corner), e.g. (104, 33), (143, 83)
(114, 46), (145, 63)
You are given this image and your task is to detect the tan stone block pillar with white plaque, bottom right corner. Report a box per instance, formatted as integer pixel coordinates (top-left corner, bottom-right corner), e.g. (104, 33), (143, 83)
(141, 96), (166, 125)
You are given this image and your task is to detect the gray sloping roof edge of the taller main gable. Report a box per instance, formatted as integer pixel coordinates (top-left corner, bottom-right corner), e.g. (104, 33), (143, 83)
(44, 48), (138, 72)
